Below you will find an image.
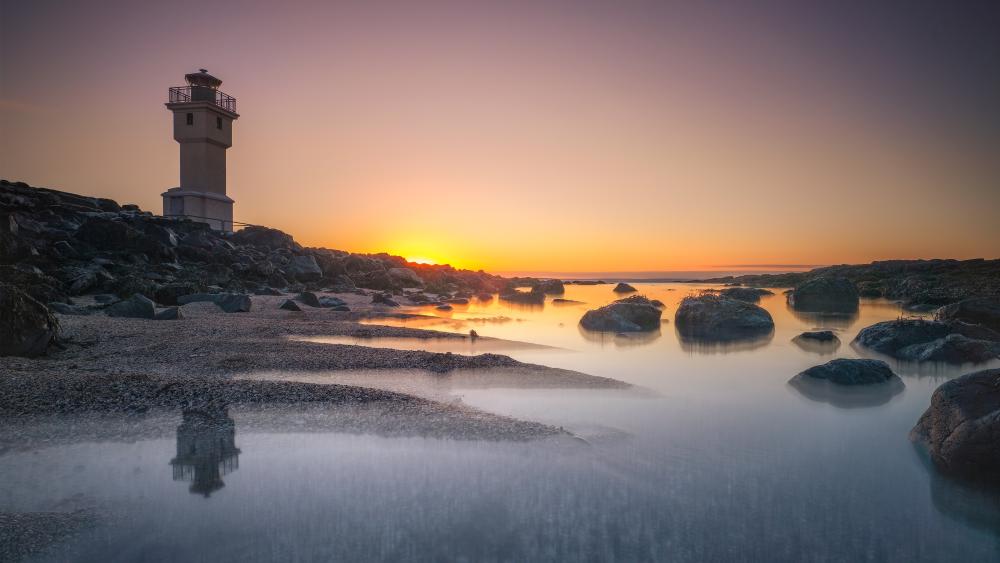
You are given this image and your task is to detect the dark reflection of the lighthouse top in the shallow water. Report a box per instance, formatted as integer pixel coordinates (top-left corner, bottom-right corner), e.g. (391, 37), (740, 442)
(170, 406), (240, 497)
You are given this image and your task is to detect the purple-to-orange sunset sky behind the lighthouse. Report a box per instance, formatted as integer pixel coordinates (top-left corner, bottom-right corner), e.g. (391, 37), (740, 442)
(0, 0), (1000, 272)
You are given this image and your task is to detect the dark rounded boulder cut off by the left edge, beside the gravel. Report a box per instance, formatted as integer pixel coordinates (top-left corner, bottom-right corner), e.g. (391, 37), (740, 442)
(0, 283), (59, 358)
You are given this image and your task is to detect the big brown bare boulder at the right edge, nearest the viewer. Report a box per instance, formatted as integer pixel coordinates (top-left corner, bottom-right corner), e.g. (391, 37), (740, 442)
(910, 369), (1000, 481)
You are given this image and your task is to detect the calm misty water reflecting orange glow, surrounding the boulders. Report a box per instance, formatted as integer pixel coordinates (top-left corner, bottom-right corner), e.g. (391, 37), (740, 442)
(0, 284), (1000, 561)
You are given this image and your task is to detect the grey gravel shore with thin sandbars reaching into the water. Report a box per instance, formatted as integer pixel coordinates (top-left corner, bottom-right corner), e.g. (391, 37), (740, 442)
(0, 295), (629, 440)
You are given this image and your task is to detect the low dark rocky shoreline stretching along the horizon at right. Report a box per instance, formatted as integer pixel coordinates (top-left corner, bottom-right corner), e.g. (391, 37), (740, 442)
(704, 258), (1000, 310)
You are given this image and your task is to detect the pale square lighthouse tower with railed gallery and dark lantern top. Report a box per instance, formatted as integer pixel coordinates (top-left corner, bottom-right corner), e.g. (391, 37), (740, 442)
(163, 69), (239, 232)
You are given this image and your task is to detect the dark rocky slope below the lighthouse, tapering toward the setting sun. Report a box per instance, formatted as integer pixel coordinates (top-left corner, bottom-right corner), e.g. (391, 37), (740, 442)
(0, 181), (508, 305)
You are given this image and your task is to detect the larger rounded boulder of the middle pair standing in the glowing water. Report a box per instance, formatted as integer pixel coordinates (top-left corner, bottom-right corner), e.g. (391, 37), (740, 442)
(674, 293), (774, 340)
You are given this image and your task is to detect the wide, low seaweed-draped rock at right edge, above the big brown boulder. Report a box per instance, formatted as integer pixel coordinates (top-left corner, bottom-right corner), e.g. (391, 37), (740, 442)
(854, 319), (1000, 364)
